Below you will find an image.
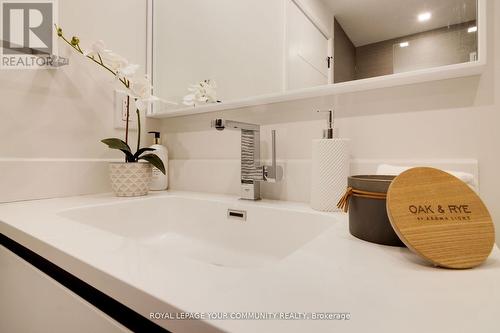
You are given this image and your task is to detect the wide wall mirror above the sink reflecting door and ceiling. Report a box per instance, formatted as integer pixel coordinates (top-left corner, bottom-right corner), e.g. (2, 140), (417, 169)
(151, 0), (478, 112)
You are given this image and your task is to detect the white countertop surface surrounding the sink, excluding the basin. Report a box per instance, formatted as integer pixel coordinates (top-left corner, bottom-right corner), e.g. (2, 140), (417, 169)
(0, 192), (500, 333)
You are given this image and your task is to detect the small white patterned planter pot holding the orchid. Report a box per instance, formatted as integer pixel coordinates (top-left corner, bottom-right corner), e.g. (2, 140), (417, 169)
(109, 163), (152, 197)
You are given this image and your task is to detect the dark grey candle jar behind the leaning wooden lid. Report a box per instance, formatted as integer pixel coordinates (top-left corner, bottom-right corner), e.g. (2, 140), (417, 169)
(348, 176), (405, 247)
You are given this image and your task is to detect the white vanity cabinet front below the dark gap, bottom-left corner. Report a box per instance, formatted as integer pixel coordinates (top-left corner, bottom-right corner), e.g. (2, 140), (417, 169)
(0, 246), (130, 333)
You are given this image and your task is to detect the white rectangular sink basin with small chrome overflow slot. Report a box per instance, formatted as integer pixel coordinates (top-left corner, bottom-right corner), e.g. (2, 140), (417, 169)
(58, 195), (336, 267)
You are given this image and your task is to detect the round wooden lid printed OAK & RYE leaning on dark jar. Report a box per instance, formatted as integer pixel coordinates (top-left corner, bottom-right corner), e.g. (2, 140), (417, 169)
(387, 168), (495, 269)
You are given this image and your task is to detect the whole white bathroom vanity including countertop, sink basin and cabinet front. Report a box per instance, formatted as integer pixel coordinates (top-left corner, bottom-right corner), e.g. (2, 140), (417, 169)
(0, 192), (500, 332)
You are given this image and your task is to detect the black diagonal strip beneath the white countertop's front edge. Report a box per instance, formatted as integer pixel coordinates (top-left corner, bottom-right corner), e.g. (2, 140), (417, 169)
(0, 233), (169, 333)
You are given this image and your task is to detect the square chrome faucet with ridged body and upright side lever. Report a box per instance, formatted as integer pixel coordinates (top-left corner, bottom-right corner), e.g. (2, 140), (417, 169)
(212, 119), (283, 200)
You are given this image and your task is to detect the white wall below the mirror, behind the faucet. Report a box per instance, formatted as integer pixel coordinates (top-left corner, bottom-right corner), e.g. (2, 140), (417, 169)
(162, 1), (500, 241)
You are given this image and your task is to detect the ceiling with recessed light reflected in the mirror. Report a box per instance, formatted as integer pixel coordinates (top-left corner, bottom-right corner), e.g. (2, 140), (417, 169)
(322, 0), (477, 46)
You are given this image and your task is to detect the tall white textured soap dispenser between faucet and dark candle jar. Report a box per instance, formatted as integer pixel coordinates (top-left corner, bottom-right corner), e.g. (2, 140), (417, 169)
(311, 110), (350, 212)
